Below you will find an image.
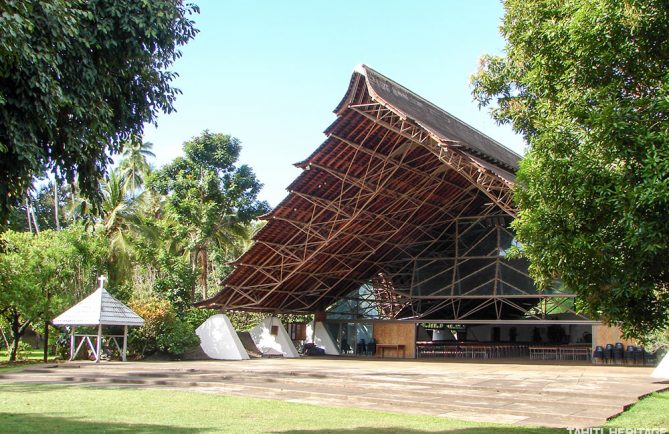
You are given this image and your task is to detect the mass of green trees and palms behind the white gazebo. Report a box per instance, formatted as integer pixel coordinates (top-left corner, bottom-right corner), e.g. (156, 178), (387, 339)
(0, 133), (267, 356)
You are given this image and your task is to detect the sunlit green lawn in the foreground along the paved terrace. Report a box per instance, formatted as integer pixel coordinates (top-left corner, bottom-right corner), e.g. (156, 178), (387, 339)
(0, 384), (669, 434)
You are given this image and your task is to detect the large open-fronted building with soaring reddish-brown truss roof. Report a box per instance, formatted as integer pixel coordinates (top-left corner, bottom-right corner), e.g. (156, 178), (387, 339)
(199, 65), (596, 360)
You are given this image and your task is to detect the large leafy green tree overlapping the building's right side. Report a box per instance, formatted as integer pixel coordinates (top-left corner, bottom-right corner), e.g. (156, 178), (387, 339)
(472, 0), (669, 336)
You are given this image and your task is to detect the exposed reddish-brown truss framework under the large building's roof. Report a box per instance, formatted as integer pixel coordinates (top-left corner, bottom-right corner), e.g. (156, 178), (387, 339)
(198, 65), (580, 318)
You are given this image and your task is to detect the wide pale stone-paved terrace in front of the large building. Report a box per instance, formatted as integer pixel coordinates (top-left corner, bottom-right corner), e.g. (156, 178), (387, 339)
(0, 357), (669, 427)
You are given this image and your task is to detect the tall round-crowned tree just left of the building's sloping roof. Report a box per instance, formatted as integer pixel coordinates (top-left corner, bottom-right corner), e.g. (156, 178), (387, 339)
(151, 131), (269, 297)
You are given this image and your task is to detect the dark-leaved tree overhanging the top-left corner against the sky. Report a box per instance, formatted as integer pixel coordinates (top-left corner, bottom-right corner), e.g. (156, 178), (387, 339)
(0, 0), (199, 224)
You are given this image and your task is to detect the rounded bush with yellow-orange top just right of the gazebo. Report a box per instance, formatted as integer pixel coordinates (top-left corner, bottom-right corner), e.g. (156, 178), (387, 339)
(128, 295), (199, 357)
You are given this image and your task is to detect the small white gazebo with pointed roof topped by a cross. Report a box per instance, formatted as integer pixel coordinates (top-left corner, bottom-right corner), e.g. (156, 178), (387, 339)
(52, 276), (144, 363)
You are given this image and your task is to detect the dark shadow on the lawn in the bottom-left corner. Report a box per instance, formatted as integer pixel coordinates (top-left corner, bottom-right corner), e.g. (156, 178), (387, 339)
(0, 413), (206, 434)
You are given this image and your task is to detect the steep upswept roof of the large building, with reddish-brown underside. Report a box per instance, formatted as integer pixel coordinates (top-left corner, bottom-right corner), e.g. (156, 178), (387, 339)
(197, 65), (520, 312)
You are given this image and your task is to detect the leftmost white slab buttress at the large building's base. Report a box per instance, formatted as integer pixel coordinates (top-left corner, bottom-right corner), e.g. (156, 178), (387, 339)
(195, 314), (249, 360)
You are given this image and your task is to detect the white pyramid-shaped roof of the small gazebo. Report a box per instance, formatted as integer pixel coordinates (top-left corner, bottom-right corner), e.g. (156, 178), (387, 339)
(52, 288), (144, 326)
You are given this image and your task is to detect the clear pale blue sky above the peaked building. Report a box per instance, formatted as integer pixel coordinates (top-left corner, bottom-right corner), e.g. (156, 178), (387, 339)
(144, 0), (524, 206)
